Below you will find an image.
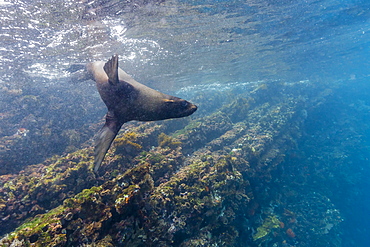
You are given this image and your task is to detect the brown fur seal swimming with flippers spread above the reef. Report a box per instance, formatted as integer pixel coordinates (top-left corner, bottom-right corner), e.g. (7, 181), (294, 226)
(87, 55), (197, 172)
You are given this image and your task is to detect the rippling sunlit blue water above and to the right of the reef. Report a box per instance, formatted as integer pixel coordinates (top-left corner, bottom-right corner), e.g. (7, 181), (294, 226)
(0, 0), (370, 247)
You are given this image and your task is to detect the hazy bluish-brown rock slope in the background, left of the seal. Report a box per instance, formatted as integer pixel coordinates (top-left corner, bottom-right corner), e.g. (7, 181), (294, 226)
(0, 83), (103, 175)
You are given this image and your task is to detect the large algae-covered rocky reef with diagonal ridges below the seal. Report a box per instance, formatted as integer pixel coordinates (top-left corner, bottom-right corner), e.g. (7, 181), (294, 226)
(0, 81), (350, 247)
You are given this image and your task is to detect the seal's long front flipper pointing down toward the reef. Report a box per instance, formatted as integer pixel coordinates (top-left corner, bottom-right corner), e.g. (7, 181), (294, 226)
(94, 112), (122, 172)
